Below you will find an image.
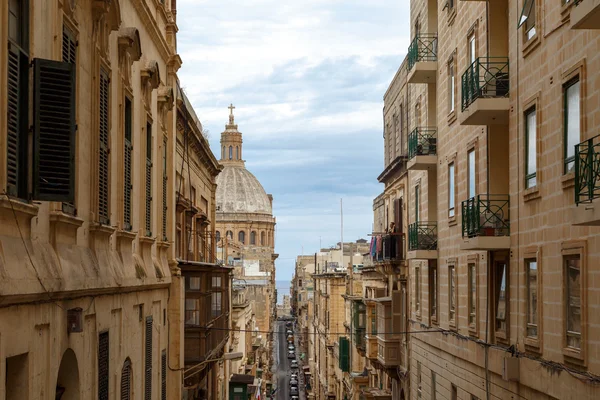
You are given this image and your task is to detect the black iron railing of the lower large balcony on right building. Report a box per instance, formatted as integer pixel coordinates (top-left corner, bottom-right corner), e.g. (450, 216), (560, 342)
(462, 194), (510, 237)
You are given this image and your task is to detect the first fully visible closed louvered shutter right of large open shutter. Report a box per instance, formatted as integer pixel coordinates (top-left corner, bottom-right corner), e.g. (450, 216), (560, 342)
(98, 70), (110, 225)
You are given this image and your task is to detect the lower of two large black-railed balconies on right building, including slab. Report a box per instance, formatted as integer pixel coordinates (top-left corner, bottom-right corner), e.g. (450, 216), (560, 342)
(460, 194), (510, 250)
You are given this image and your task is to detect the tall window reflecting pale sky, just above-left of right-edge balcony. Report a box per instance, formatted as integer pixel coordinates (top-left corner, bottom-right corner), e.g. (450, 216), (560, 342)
(564, 77), (581, 173)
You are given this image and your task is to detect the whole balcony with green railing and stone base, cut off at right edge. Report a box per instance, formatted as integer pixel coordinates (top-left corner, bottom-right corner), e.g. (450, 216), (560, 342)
(572, 135), (600, 226)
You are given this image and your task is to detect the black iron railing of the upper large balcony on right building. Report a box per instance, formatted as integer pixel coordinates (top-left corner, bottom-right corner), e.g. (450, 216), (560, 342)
(461, 57), (509, 111)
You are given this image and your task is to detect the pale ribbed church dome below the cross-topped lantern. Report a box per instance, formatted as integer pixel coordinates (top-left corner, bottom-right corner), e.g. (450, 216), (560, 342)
(217, 165), (272, 215)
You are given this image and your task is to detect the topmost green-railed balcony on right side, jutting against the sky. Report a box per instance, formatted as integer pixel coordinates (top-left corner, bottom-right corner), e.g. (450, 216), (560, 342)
(408, 33), (437, 83)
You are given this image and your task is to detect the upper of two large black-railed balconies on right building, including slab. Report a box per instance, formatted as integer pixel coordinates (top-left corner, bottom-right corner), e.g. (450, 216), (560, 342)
(460, 57), (510, 125)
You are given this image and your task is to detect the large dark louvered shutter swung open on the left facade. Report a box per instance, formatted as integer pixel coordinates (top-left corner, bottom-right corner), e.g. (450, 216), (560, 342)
(33, 58), (75, 203)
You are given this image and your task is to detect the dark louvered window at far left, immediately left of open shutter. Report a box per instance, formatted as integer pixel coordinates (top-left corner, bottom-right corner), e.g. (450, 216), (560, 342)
(6, 1), (29, 198)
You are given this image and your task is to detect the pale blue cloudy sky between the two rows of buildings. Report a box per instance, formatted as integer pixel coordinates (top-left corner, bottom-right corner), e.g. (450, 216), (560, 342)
(177, 0), (409, 280)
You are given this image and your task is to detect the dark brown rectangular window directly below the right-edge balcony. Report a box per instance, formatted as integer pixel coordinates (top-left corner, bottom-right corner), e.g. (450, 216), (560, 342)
(564, 254), (581, 350)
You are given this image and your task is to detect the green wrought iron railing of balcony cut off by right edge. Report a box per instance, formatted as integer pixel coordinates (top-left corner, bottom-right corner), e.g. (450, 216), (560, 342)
(575, 135), (600, 204)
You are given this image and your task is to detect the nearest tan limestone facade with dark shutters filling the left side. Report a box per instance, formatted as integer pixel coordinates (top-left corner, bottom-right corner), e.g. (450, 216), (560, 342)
(0, 0), (180, 399)
